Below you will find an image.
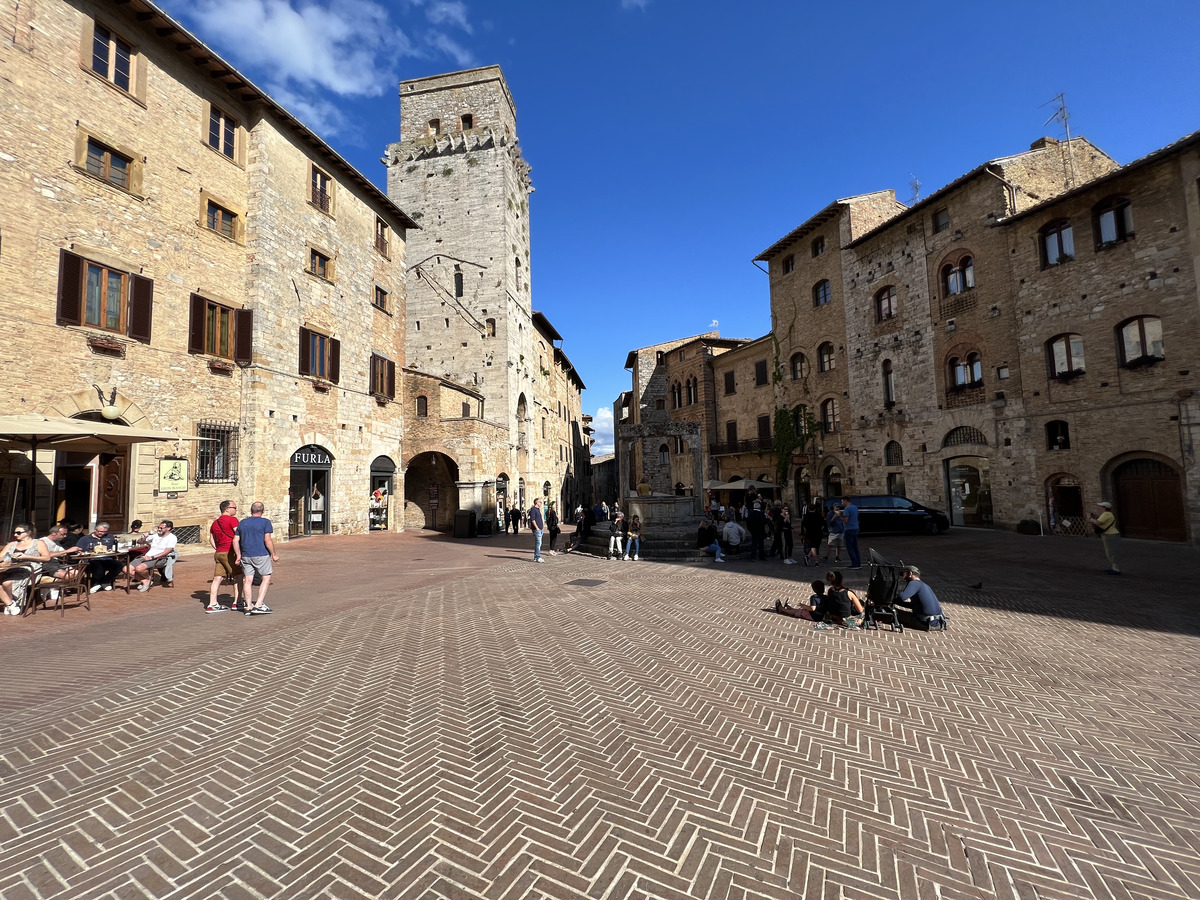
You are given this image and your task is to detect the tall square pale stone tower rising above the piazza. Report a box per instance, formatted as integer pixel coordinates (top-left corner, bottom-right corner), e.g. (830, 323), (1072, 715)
(386, 66), (535, 499)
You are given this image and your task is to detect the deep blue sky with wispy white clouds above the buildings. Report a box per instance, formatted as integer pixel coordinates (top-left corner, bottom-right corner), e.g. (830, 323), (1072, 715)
(160, 0), (1200, 454)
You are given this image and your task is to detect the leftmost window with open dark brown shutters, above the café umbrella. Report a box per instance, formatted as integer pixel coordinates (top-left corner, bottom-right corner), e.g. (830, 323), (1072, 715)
(56, 250), (154, 343)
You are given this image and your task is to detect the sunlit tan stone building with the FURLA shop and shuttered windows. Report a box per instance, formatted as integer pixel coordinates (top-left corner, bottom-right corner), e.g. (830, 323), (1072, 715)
(0, 0), (413, 539)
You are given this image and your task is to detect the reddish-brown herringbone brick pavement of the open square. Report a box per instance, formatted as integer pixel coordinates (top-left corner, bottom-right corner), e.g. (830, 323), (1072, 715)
(0, 534), (1200, 900)
